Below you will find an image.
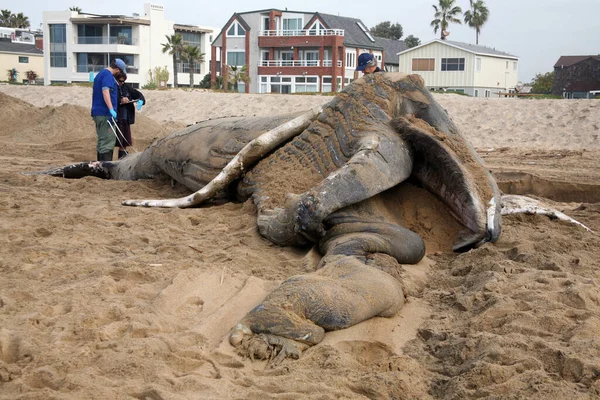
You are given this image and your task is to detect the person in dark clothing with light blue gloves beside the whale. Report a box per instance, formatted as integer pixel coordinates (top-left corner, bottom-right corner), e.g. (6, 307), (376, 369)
(115, 73), (146, 159)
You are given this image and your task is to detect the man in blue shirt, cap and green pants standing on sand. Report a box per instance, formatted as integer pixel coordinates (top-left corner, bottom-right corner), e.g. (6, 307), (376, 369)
(92, 58), (127, 161)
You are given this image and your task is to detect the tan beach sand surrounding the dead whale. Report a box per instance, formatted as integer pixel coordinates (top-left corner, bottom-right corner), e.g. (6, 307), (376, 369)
(0, 85), (600, 400)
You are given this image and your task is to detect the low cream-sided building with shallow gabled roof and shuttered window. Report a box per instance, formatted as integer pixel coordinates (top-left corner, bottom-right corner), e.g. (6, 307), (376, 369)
(398, 39), (519, 97)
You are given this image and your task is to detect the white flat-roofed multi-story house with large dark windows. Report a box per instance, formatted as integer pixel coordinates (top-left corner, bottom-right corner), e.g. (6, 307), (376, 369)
(43, 3), (213, 86)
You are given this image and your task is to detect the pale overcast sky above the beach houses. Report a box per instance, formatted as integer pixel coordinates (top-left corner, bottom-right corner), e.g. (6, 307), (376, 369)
(15, 0), (600, 82)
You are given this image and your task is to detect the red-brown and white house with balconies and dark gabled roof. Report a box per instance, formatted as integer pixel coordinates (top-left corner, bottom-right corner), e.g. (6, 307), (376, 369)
(210, 9), (385, 93)
